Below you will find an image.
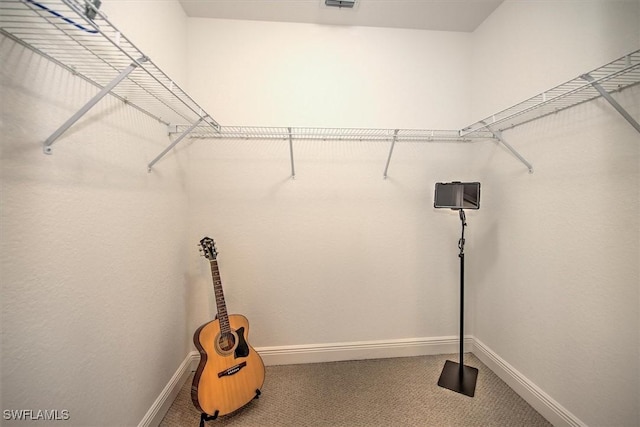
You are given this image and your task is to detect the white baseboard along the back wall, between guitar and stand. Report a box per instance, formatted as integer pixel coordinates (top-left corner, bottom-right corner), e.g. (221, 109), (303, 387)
(256, 337), (472, 366)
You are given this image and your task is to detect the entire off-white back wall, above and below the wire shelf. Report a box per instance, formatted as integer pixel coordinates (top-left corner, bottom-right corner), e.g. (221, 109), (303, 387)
(188, 19), (476, 352)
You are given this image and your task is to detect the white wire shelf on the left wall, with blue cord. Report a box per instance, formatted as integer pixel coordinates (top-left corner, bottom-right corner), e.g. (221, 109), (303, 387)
(0, 0), (219, 129)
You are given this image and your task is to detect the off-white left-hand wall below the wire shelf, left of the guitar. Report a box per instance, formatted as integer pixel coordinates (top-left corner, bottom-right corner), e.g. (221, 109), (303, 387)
(0, 2), (191, 426)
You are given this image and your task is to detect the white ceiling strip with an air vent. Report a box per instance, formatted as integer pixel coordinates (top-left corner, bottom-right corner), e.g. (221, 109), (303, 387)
(179, 0), (504, 32)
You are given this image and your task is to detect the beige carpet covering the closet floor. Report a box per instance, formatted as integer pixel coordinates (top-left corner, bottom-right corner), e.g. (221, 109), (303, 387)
(160, 354), (551, 427)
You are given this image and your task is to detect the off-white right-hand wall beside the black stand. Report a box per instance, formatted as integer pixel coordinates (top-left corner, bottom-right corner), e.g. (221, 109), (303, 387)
(469, 1), (640, 426)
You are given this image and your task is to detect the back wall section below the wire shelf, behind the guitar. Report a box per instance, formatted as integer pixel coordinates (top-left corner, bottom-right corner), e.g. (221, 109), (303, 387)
(189, 141), (484, 352)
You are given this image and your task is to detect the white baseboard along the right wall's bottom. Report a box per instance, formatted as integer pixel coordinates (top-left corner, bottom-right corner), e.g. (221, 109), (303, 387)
(473, 338), (586, 427)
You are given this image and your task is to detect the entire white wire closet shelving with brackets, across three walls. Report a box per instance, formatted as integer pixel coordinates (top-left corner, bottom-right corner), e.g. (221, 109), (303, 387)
(0, 0), (640, 177)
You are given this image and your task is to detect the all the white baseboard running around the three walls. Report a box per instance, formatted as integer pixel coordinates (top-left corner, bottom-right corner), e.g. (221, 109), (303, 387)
(138, 336), (586, 427)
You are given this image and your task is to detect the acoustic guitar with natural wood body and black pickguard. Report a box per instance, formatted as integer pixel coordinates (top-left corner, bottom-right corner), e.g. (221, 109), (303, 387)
(191, 237), (264, 417)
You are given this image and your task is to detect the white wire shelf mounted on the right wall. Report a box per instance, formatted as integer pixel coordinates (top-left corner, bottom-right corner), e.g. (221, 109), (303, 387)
(460, 50), (640, 136)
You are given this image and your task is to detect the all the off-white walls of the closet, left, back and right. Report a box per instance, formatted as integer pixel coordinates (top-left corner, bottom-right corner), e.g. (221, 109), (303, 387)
(0, 1), (640, 425)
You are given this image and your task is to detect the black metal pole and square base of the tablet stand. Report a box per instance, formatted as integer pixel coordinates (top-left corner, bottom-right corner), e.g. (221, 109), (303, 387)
(438, 209), (478, 397)
